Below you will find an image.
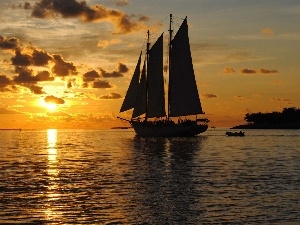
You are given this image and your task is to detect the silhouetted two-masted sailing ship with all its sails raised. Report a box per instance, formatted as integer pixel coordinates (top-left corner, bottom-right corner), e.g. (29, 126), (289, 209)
(118, 14), (209, 137)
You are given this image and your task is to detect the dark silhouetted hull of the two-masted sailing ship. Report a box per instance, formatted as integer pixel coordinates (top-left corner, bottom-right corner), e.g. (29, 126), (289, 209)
(131, 122), (208, 137)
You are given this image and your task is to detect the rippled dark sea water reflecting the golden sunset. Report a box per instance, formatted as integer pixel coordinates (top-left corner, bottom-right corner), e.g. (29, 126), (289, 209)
(0, 129), (300, 224)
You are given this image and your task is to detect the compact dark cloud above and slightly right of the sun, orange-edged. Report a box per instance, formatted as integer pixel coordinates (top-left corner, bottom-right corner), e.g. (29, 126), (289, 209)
(52, 55), (77, 77)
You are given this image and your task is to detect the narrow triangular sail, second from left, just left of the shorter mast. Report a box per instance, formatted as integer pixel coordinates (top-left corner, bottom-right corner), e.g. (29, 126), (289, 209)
(132, 60), (147, 118)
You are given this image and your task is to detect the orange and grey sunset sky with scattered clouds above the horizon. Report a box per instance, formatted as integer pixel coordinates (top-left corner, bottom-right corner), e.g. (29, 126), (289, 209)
(0, 0), (300, 129)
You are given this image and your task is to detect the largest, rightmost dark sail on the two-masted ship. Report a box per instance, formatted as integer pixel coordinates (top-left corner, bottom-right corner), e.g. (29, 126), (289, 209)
(169, 18), (203, 116)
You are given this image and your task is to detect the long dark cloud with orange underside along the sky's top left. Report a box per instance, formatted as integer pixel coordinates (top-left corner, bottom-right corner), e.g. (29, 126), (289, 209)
(31, 0), (147, 34)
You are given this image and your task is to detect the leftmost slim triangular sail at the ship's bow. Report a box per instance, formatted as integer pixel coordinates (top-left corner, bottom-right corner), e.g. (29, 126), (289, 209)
(120, 53), (142, 112)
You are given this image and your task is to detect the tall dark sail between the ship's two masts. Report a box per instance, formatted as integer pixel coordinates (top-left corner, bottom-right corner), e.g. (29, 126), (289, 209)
(147, 34), (166, 118)
